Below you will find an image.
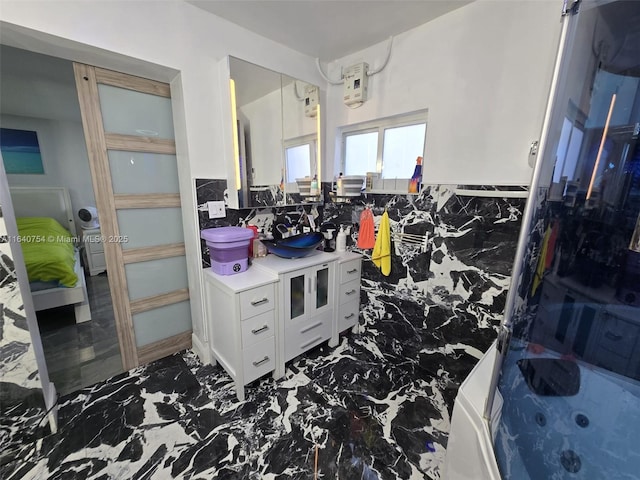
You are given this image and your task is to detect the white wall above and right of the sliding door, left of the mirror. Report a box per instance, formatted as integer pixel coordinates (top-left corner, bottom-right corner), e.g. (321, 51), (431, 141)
(0, 0), (321, 352)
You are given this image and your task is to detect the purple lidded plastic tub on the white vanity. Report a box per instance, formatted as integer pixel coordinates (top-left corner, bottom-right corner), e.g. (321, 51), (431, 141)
(200, 227), (254, 275)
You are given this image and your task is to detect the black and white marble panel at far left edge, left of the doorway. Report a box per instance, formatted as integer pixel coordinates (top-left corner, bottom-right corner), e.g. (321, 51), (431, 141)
(0, 205), (49, 462)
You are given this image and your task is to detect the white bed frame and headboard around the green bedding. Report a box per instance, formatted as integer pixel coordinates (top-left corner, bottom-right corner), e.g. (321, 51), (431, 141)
(10, 187), (91, 323)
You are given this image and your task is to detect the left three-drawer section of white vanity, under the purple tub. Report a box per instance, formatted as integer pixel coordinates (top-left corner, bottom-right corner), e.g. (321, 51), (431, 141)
(204, 268), (278, 400)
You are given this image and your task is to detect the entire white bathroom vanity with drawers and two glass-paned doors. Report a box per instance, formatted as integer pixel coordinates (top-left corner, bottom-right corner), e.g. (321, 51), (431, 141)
(204, 251), (361, 400)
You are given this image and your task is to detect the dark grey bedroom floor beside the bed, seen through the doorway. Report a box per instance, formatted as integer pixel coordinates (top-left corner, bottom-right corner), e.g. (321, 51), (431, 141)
(37, 273), (123, 395)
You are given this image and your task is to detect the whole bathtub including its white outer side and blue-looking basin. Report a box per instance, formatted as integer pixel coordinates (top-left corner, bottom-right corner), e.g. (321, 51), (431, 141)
(442, 340), (640, 480)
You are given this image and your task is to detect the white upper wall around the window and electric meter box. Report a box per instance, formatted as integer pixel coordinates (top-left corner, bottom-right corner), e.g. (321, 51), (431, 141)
(324, 0), (562, 184)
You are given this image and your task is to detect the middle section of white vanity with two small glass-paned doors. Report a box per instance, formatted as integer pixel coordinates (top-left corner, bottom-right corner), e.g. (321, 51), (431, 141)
(252, 251), (337, 377)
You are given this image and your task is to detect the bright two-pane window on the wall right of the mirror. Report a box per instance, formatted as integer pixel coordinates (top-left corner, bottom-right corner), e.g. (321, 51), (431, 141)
(341, 110), (427, 178)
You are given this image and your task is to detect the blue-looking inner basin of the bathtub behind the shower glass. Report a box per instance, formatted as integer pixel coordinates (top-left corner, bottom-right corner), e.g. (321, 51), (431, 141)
(494, 342), (640, 480)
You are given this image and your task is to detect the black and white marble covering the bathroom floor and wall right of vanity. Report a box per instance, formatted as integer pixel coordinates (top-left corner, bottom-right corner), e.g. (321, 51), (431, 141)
(0, 186), (524, 480)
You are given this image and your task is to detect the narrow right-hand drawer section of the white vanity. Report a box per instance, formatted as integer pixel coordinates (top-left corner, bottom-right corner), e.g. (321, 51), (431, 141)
(329, 253), (362, 346)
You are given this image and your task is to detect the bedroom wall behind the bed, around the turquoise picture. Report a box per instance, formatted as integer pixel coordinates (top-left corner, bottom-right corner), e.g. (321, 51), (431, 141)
(0, 115), (96, 231)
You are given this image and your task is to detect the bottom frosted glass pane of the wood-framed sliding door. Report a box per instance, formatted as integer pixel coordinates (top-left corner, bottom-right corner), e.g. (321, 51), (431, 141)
(133, 300), (191, 347)
